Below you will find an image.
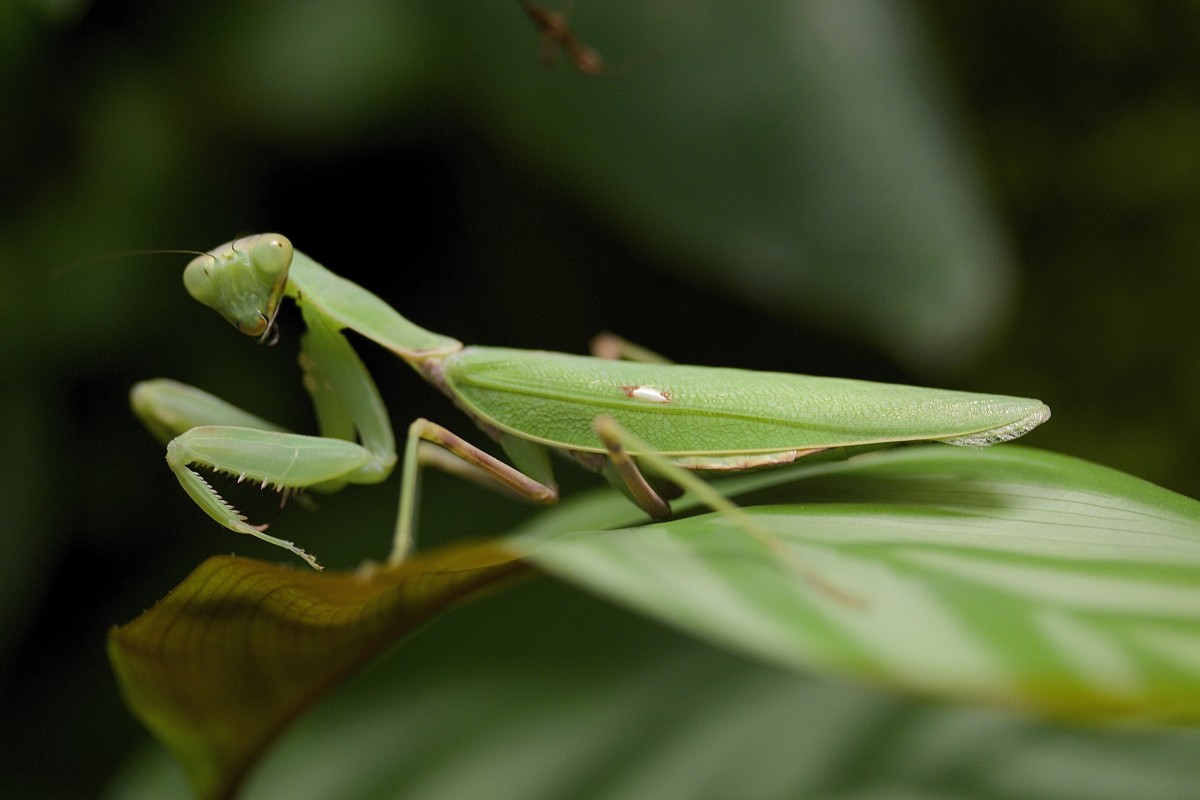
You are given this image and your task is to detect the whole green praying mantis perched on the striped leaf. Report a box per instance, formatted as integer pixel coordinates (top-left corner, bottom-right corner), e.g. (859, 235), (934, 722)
(131, 234), (1050, 578)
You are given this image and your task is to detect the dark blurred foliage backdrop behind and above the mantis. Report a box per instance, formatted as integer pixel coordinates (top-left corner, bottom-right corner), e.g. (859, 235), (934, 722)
(0, 0), (1200, 798)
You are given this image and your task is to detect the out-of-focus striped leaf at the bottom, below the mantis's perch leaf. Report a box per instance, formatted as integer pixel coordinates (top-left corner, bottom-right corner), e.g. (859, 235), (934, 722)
(104, 581), (1200, 800)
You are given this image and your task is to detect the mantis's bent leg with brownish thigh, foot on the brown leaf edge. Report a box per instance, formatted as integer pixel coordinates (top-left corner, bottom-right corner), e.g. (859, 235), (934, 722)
(388, 419), (558, 564)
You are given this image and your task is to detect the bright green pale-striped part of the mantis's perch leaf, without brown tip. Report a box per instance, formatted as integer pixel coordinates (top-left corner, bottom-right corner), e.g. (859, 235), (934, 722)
(514, 445), (1200, 722)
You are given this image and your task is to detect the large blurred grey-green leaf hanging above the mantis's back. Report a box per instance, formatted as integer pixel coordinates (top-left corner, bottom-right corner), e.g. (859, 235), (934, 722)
(427, 0), (1013, 372)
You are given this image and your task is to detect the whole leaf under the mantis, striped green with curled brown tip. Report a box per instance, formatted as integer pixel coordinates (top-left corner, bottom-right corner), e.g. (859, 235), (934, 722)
(112, 445), (1200, 796)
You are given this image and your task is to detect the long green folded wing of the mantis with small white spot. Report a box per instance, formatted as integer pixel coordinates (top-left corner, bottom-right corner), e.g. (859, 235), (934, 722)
(444, 347), (1050, 458)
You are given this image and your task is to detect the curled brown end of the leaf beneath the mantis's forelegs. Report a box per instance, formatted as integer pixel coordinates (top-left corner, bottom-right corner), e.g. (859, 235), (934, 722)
(109, 543), (528, 798)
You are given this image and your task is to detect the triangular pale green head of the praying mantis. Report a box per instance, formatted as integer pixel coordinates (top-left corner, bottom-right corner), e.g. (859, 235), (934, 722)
(184, 234), (292, 343)
